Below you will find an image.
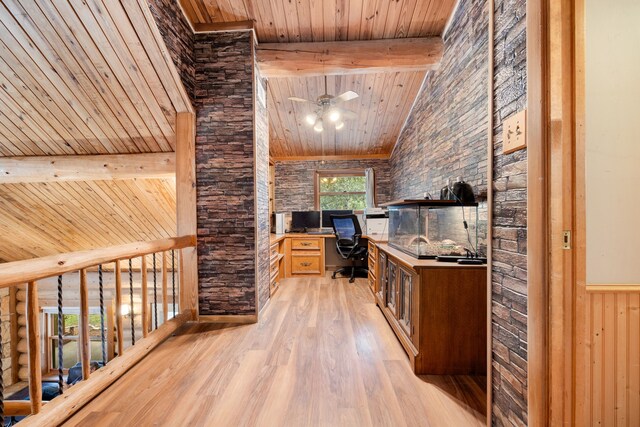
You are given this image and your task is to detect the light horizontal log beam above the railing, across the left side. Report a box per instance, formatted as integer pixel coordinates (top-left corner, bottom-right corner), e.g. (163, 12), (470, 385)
(0, 152), (176, 184)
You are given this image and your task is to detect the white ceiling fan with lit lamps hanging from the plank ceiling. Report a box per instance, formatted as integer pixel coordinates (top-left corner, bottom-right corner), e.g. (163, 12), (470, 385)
(289, 76), (358, 132)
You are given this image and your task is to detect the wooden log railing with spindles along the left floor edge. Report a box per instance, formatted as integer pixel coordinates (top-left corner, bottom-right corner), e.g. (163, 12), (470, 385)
(0, 236), (196, 426)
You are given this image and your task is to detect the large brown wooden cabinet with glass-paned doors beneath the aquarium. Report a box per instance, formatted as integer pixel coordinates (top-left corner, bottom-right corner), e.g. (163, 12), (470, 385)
(375, 244), (487, 375)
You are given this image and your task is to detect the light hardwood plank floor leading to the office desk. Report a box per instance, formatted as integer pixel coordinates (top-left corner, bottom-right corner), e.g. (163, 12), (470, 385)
(66, 277), (486, 427)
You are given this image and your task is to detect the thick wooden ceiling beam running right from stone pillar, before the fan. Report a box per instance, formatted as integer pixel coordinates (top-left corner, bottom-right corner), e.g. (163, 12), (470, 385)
(252, 37), (444, 78)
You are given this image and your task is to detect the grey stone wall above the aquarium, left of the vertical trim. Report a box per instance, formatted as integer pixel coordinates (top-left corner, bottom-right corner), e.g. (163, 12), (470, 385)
(390, 0), (488, 199)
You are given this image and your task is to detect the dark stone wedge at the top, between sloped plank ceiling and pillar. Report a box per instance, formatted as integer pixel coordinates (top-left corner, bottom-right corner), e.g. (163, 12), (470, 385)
(148, 0), (196, 102)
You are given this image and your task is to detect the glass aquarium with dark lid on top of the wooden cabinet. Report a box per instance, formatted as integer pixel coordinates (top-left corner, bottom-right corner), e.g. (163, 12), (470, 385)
(387, 200), (478, 259)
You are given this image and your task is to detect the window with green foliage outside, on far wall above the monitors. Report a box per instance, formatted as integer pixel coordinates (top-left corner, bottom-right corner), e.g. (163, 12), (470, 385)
(315, 170), (367, 210)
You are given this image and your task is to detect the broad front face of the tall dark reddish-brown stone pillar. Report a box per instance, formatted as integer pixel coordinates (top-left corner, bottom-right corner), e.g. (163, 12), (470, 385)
(195, 31), (257, 315)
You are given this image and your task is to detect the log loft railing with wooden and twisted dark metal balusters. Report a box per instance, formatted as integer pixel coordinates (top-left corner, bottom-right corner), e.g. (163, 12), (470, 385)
(0, 236), (196, 426)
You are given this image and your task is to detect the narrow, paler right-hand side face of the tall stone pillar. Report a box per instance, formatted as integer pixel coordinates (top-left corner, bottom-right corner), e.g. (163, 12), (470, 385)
(255, 66), (271, 310)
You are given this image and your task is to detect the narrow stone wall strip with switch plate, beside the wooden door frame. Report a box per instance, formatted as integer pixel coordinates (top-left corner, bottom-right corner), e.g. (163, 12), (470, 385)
(491, 0), (527, 426)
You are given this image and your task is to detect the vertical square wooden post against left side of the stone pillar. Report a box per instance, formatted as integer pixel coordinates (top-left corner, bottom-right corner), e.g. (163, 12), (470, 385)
(176, 113), (198, 319)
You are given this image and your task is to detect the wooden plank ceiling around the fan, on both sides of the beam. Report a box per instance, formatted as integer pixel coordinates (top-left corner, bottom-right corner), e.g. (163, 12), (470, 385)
(180, 0), (456, 158)
